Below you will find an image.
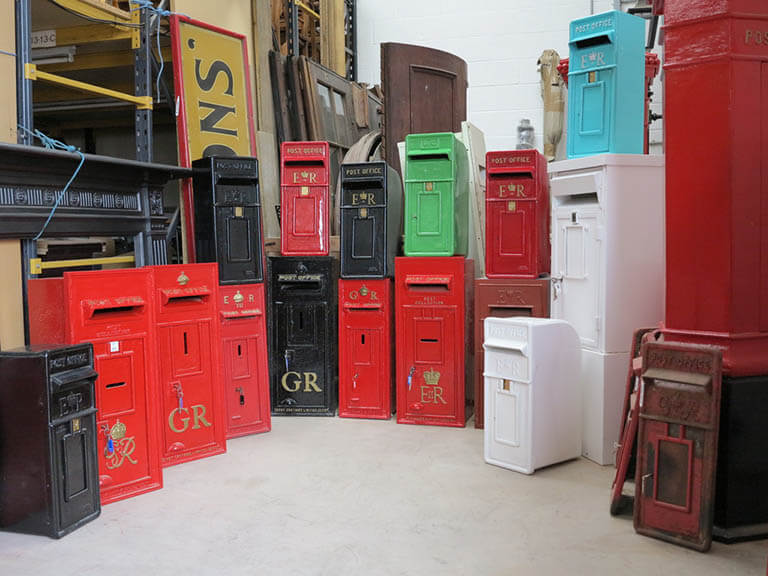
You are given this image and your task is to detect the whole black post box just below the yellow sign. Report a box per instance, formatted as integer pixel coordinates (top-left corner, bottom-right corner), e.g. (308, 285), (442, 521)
(192, 157), (264, 284)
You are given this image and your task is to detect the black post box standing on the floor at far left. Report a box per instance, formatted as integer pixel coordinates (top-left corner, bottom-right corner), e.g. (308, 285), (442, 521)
(0, 344), (101, 538)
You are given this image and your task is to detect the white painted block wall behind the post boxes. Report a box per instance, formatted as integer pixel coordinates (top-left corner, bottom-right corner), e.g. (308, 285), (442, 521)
(357, 0), (661, 158)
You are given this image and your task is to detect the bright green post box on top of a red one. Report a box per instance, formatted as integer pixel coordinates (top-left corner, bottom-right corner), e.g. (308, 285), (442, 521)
(404, 132), (469, 256)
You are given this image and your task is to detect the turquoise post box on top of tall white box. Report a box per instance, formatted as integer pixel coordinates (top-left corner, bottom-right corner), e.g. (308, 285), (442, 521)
(567, 11), (645, 158)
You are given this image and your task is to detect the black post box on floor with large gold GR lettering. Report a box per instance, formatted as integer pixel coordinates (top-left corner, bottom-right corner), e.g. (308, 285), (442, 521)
(268, 257), (339, 416)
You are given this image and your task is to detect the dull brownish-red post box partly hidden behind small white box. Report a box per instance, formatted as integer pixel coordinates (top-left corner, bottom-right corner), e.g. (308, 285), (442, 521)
(474, 276), (550, 428)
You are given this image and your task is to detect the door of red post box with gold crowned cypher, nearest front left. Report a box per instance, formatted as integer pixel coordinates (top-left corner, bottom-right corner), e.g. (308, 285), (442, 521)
(93, 337), (156, 503)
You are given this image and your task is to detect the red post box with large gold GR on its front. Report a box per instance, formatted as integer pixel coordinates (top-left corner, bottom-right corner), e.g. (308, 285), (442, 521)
(152, 263), (226, 466)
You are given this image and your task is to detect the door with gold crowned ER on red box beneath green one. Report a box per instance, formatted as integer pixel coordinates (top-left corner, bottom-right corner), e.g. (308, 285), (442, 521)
(398, 306), (464, 424)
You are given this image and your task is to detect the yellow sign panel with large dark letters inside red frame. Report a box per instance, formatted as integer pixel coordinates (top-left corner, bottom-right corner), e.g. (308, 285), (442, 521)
(176, 19), (252, 161)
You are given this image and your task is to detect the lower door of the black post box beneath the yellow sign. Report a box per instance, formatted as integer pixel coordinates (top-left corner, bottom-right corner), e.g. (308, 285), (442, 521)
(214, 206), (264, 284)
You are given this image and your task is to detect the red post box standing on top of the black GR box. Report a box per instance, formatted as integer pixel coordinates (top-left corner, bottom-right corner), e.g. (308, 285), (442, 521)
(280, 142), (330, 256)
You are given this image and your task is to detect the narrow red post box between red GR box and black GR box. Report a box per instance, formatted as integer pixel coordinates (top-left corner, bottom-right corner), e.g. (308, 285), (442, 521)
(219, 284), (272, 438)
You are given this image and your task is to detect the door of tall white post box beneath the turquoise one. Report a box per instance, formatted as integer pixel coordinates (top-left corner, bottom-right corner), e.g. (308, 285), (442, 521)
(552, 206), (604, 348)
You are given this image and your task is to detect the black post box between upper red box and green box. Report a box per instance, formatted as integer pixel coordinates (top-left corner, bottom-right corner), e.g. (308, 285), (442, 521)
(340, 162), (403, 278)
